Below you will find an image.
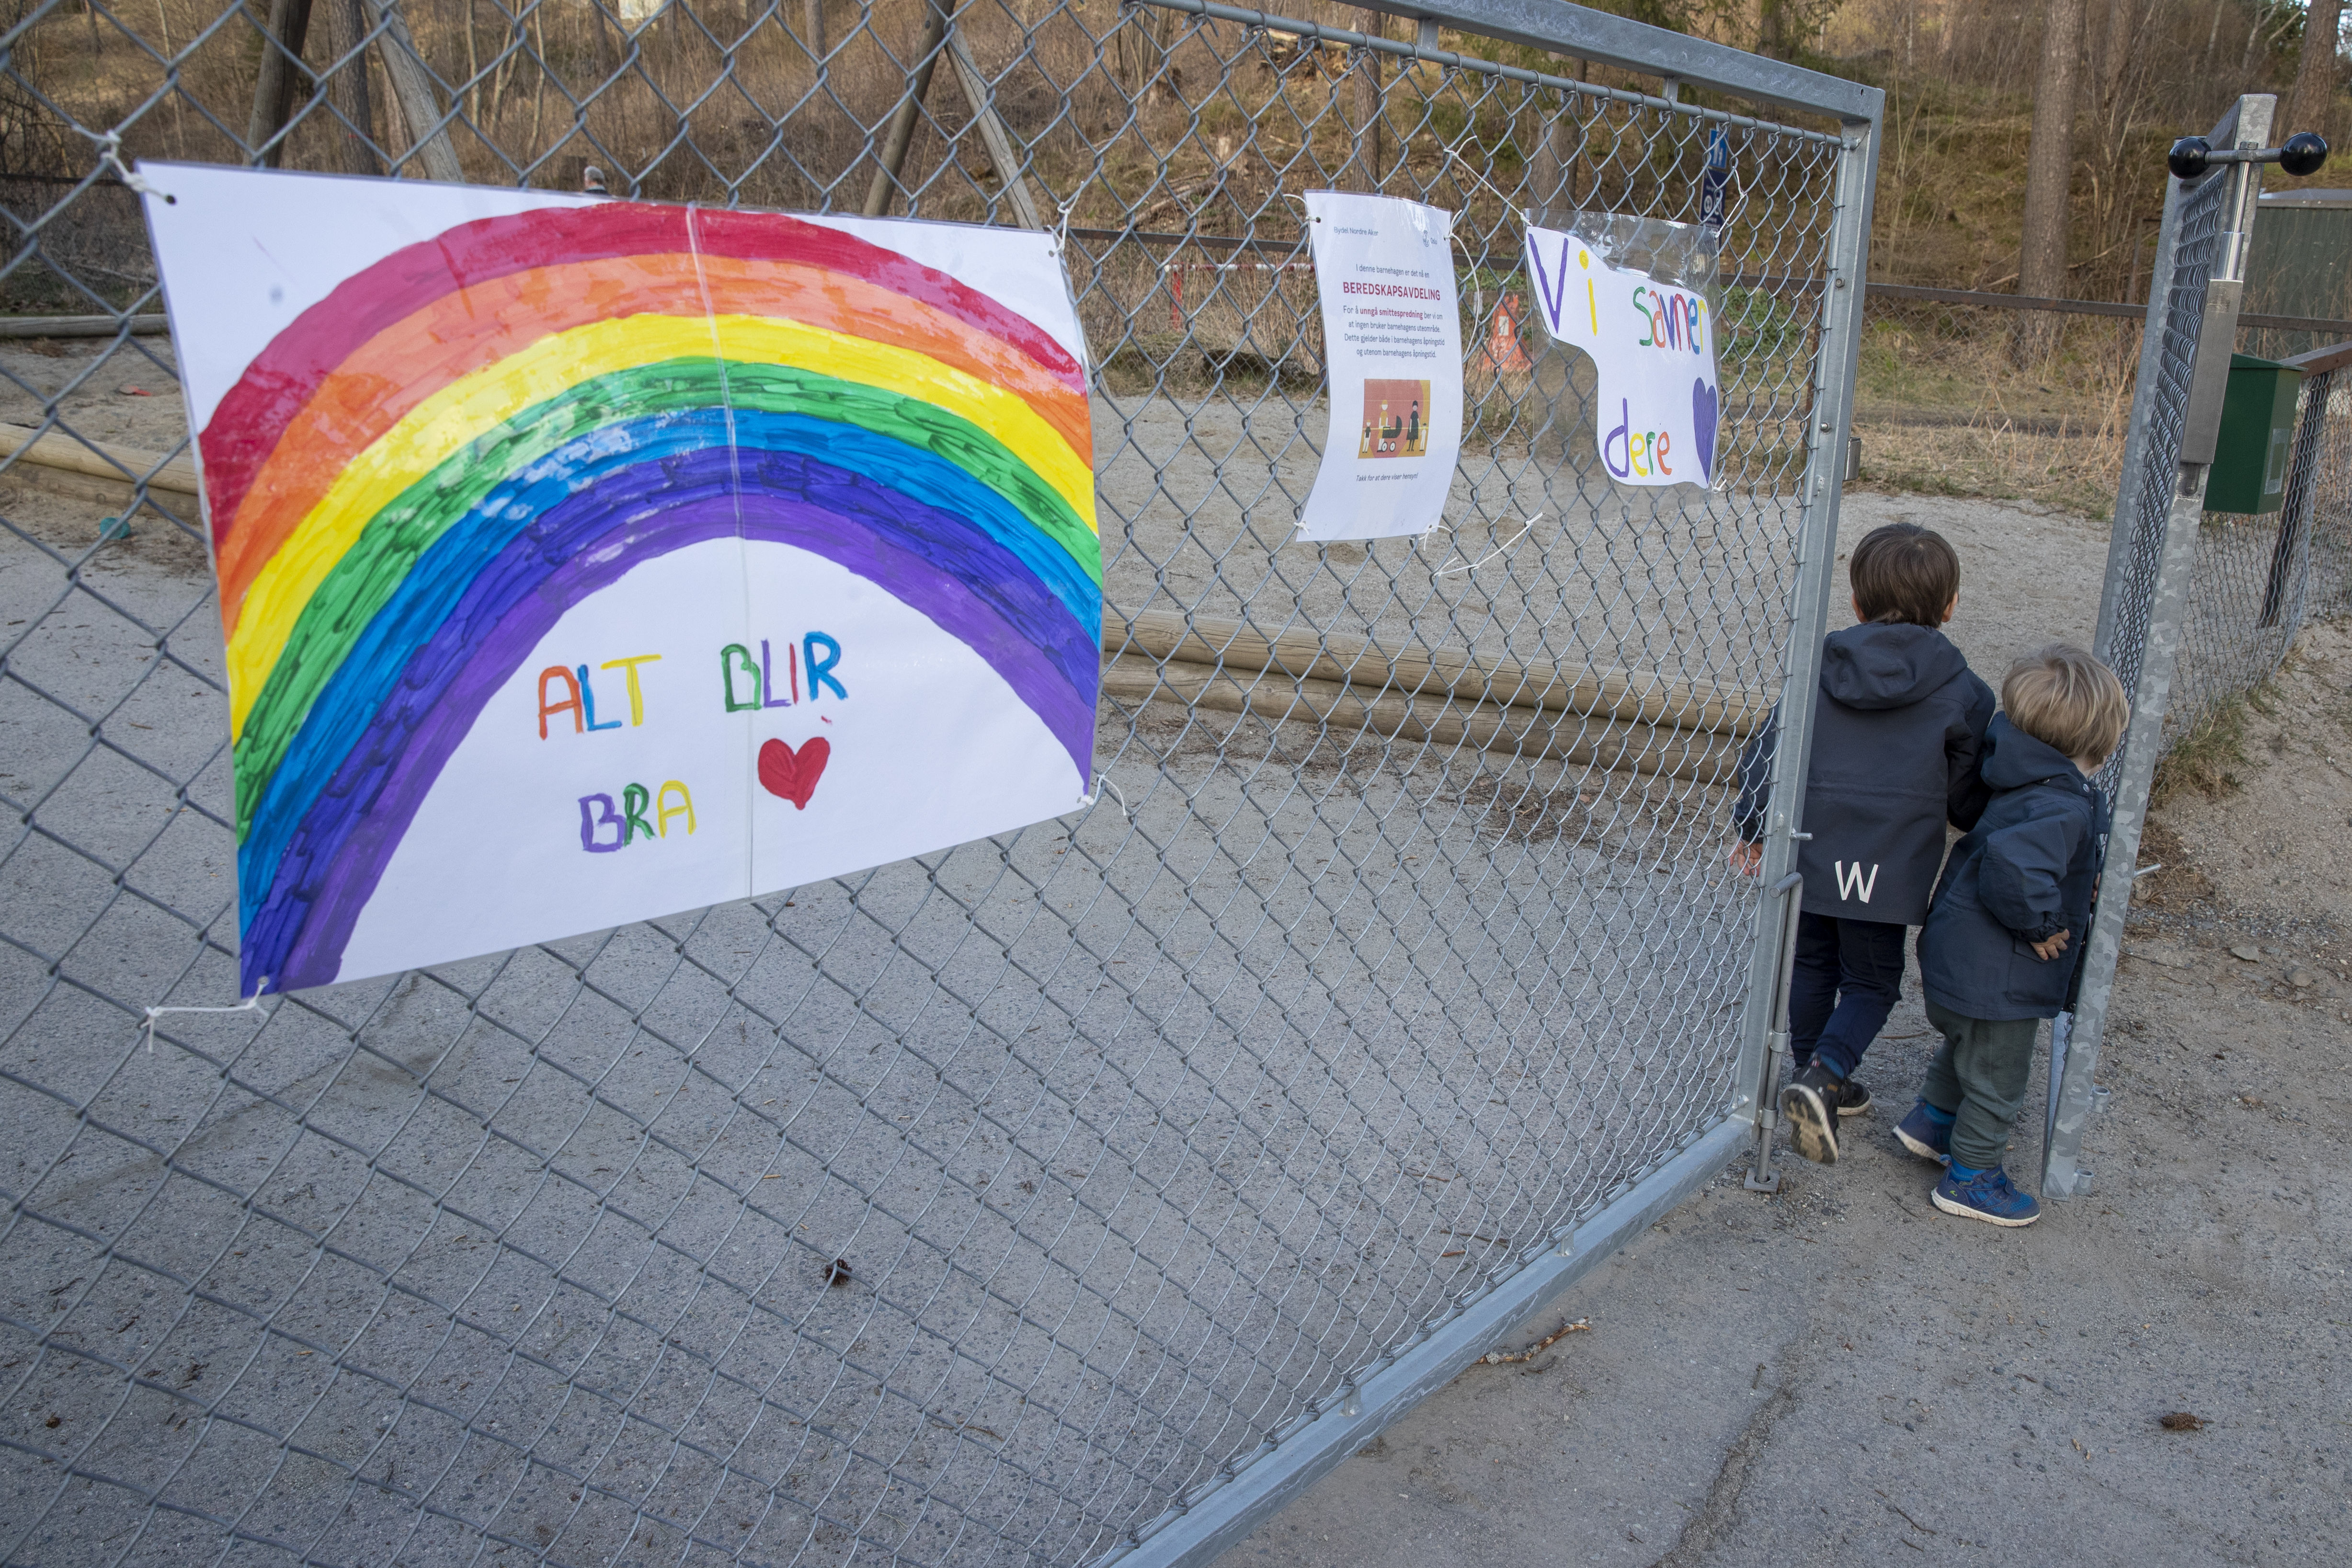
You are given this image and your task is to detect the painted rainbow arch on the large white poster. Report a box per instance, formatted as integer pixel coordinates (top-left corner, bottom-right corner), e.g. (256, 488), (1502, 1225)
(197, 202), (1103, 995)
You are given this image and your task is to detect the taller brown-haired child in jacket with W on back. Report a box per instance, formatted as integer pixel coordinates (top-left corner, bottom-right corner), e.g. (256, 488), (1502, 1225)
(1731, 522), (1992, 1164)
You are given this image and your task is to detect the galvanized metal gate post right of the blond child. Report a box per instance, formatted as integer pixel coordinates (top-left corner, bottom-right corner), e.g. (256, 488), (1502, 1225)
(2042, 94), (2277, 1202)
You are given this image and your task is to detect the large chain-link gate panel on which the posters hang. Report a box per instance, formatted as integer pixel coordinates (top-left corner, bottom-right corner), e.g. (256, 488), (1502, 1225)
(0, 0), (1877, 1563)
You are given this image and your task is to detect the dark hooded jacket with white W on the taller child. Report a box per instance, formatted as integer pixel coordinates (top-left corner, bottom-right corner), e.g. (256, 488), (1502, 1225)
(1734, 620), (1995, 926)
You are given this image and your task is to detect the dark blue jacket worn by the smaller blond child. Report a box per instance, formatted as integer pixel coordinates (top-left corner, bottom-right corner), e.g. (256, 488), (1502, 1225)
(1919, 715), (2107, 1018)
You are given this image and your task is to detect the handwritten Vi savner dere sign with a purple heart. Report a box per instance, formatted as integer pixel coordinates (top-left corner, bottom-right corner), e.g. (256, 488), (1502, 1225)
(1527, 228), (1722, 484)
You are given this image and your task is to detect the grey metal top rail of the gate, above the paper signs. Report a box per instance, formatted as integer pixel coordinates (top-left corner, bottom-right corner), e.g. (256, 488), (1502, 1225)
(1367, 0), (1886, 125)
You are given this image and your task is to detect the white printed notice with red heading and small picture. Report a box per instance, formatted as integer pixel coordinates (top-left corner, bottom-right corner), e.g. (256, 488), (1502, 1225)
(1298, 190), (1463, 538)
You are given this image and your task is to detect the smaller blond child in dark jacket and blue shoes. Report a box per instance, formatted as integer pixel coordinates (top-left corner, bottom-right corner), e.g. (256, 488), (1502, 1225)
(1895, 644), (2131, 1227)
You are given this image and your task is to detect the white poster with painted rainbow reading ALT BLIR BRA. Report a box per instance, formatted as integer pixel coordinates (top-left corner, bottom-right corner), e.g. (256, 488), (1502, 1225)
(144, 164), (1103, 995)
